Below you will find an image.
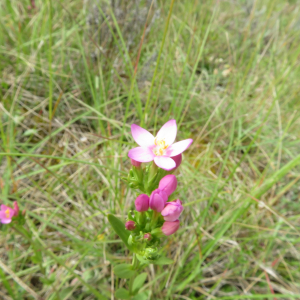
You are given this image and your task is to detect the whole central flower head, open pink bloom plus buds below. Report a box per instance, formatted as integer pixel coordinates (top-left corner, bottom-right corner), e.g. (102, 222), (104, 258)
(125, 120), (193, 261)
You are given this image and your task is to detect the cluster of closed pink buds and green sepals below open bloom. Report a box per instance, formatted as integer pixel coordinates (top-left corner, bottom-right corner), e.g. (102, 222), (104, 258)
(125, 174), (183, 260)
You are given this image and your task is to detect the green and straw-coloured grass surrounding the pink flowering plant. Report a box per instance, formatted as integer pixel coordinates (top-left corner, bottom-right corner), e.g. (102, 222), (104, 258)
(0, 0), (300, 300)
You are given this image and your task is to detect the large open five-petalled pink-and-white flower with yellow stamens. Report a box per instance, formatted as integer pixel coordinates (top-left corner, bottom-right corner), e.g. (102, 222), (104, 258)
(128, 120), (193, 171)
